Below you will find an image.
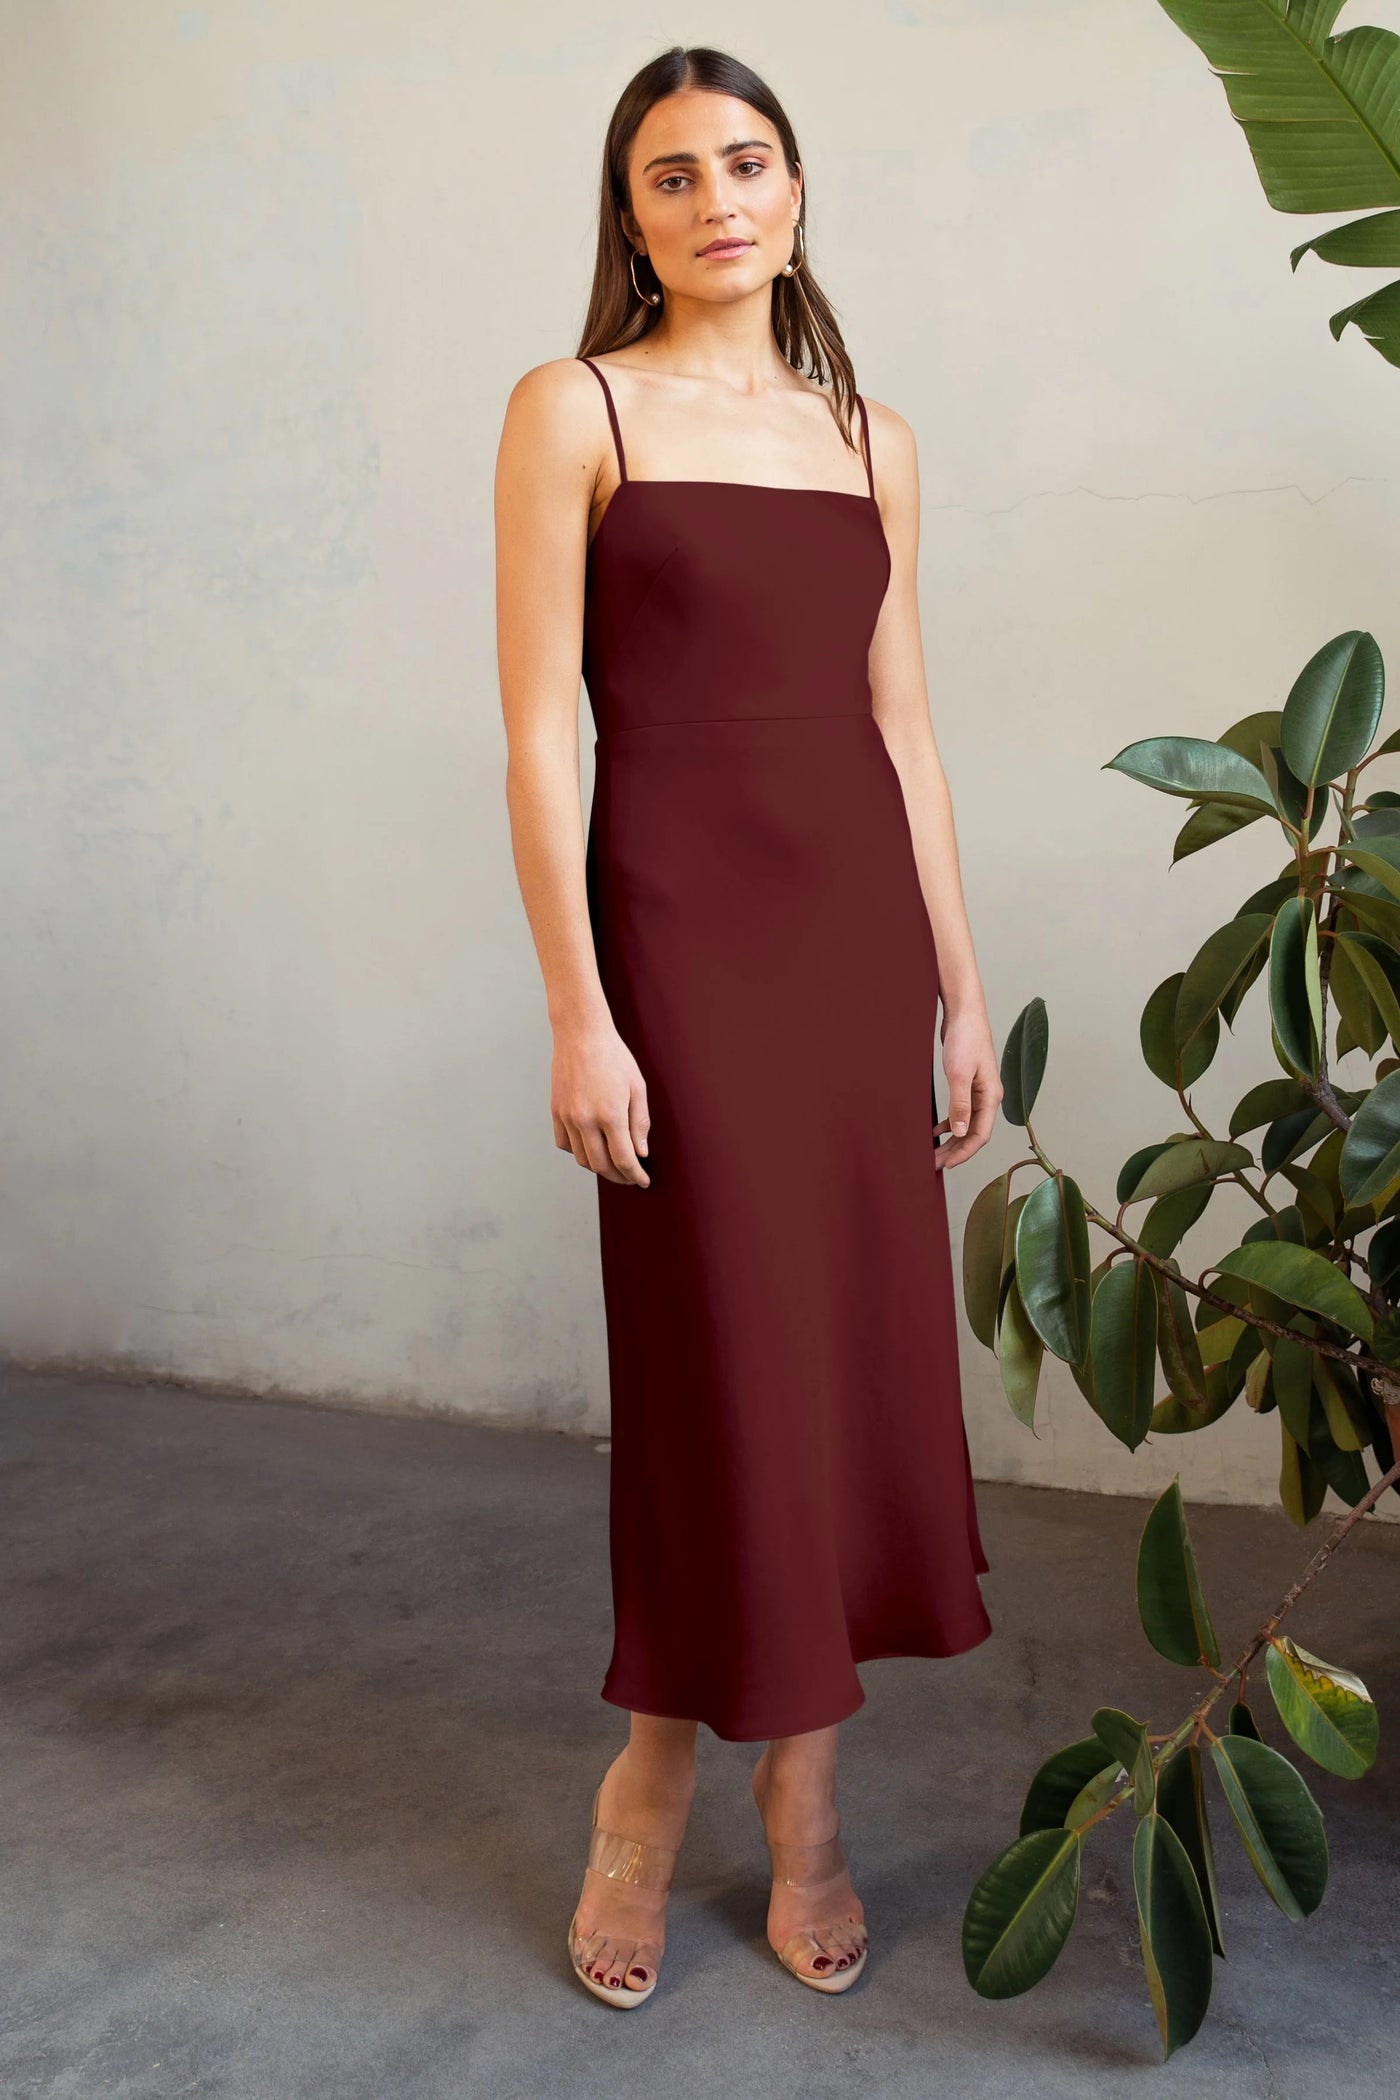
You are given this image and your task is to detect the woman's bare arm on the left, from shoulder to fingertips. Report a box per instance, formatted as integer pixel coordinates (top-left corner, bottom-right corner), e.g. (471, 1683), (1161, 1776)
(495, 357), (649, 1189)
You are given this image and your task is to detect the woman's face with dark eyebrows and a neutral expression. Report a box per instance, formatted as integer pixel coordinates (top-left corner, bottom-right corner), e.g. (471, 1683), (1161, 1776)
(623, 88), (802, 300)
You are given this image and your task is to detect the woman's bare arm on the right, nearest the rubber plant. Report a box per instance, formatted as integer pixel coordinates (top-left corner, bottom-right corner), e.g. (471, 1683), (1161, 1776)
(867, 399), (1001, 1168)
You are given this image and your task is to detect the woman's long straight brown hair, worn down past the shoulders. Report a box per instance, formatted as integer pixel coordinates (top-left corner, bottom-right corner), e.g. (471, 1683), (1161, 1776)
(577, 44), (856, 452)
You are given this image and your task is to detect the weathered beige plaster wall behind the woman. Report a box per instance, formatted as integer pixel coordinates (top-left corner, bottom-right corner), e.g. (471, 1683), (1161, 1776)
(0, 0), (1400, 1499)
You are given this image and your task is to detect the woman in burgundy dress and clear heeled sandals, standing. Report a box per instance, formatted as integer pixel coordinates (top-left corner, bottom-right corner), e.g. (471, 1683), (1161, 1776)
(497, 48), (1001, 2008)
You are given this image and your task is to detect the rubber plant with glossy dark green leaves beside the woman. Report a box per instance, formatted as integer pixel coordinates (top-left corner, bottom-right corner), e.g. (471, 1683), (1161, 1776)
(963, 632), (1400, 2056)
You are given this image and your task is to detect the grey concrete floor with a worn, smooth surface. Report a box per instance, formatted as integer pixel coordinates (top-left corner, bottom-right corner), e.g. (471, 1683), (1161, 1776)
(0, 1373), (1400, 2100)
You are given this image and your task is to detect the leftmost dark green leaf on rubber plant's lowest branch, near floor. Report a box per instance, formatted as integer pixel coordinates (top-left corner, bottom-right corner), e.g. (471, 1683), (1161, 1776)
(963, 1829), (1081, 1997)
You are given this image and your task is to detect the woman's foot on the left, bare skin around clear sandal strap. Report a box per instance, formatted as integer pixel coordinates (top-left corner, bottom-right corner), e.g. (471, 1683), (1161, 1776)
(573, 1745), (695, 1991)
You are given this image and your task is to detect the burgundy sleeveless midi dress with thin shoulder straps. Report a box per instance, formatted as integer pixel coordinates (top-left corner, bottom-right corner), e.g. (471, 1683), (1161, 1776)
(584, 359), (991, 1741)
